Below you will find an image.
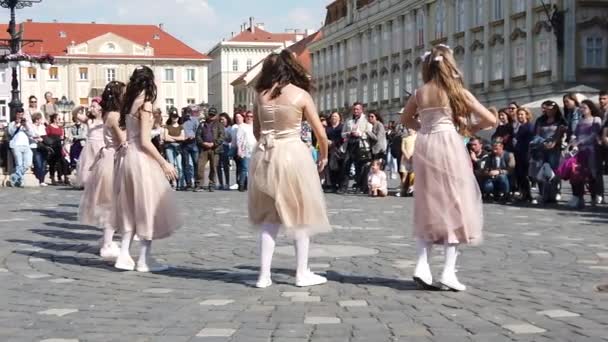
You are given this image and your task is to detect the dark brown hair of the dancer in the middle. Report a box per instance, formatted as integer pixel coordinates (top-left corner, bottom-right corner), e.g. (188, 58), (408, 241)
(255, 49), (312, 99)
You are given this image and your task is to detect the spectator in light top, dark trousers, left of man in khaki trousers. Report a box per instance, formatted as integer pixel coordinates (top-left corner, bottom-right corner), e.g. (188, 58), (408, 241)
(182, 107), (199, 190)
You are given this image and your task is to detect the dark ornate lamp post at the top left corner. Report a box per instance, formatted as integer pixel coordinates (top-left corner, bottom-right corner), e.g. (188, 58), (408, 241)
(0, 0), (42, 121)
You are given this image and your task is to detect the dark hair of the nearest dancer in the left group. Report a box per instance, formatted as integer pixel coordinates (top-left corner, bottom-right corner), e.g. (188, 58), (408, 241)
(120, 65), (157, 128)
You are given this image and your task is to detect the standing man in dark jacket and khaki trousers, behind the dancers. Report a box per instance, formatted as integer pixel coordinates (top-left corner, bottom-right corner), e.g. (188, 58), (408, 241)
(196, 107), (224, 192)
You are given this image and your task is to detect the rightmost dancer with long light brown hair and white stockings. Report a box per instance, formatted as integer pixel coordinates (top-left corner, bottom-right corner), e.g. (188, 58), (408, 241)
(402, 45), (497, 291)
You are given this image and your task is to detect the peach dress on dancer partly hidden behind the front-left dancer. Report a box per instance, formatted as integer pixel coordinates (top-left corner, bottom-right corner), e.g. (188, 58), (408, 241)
(78, 115), (119, 228)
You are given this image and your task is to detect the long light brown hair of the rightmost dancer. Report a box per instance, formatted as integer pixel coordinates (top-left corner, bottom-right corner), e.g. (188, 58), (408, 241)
(422, 45), (471, 133)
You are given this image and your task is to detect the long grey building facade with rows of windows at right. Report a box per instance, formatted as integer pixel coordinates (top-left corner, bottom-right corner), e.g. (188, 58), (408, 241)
(310, 0), (608, 116)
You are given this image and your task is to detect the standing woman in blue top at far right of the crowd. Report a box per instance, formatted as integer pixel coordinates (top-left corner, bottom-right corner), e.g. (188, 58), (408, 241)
(568, 100), (603, 209)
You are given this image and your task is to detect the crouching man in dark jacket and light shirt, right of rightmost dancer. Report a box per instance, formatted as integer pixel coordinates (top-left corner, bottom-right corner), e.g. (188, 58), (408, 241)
(482, 138), (515, 201)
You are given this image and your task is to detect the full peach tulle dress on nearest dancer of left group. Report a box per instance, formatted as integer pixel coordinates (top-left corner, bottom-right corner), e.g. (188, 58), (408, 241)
(113, 93), (182, 240)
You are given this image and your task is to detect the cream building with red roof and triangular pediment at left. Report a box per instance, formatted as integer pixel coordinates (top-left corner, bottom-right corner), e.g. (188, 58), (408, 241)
(1, 20), (211, 119)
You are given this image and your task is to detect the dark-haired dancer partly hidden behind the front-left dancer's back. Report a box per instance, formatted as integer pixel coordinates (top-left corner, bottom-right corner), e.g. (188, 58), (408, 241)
(78, 81), (125, 260)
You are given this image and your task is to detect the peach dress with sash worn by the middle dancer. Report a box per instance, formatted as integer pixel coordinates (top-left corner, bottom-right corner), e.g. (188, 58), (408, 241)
(248, 85), (331, 236)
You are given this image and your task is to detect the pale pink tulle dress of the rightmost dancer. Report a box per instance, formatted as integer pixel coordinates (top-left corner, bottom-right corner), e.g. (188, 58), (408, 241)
(413, 94), (483, 245)
